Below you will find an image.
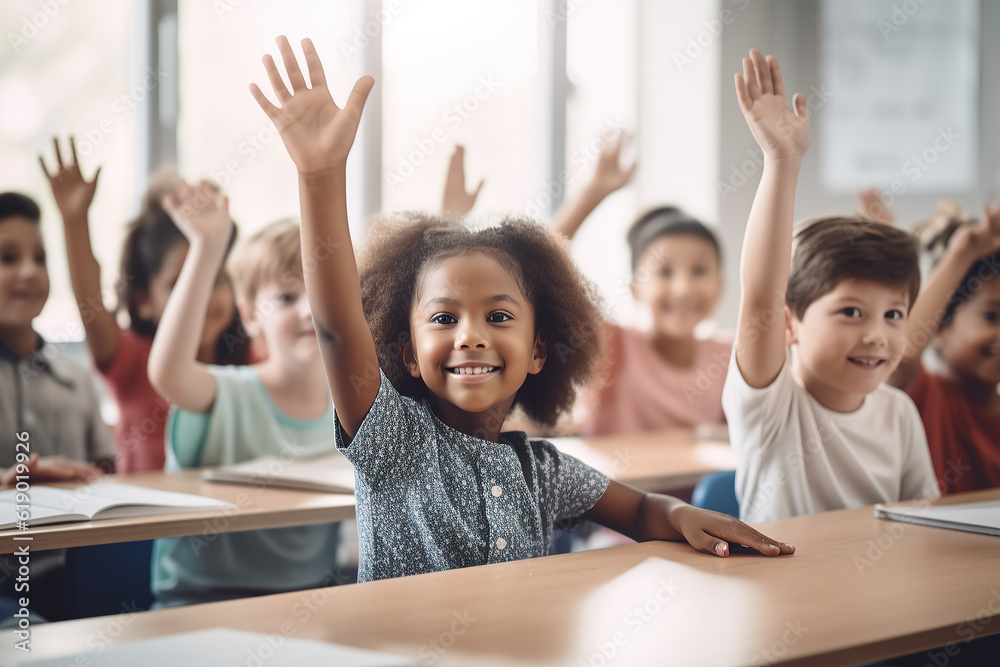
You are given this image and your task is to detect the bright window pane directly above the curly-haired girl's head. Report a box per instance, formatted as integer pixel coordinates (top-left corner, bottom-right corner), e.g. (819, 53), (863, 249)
(381, 0), (551, 217)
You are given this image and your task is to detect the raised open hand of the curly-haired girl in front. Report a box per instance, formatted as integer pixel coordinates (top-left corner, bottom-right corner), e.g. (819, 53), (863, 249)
(250, 35), (375, 175)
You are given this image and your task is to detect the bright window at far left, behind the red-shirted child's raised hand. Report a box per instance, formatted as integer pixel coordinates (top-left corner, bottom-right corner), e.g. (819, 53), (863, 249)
(0, 0), (136, 341)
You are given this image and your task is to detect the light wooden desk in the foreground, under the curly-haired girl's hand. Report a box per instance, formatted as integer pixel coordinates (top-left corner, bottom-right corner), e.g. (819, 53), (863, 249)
(0, 489), (1000, 667)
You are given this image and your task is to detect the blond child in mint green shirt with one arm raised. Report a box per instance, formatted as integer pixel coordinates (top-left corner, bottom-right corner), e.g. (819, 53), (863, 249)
(148, 182), (339, 606)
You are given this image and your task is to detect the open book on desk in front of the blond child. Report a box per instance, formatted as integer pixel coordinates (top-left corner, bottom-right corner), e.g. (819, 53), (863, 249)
(202, 452), (354, 494)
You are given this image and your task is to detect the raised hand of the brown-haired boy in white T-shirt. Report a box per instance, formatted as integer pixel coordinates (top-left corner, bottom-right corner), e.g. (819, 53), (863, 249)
(736, 49), (809, 160)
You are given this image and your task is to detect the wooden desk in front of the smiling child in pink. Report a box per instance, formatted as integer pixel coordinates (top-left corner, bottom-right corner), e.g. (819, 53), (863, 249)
(550, 430), (736, 491)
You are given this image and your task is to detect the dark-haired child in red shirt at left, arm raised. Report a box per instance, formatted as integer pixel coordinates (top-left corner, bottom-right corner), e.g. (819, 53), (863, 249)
(39, 137), (249, 473)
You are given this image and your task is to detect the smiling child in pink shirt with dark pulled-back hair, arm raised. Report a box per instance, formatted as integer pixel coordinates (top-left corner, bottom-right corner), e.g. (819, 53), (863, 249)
(553, 140), (732, 435)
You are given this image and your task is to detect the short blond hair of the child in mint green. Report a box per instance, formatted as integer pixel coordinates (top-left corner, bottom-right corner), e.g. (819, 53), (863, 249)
(229, 218), (302, 307)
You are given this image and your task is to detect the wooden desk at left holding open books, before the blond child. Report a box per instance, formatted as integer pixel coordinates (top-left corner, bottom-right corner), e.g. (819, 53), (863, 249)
(0, 471), (354, 554)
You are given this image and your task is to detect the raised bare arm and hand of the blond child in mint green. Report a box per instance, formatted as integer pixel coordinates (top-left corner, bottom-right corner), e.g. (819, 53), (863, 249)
(147, 181), (233, 412)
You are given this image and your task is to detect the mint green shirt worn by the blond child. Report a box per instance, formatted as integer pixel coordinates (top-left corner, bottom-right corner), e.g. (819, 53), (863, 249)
(153, 366), (340, 606)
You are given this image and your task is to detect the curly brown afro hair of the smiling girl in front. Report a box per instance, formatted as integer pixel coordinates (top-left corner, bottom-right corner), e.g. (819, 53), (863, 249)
(359, 212), (605, 425)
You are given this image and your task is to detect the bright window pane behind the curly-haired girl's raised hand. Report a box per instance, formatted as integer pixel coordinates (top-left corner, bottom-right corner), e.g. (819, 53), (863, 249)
(177, 0), (365, 238)
